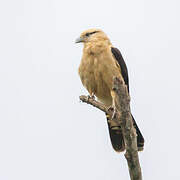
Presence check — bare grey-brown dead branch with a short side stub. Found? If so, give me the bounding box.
[80,77,142,180]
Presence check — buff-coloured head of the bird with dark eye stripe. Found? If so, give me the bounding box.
[75,29,109,44]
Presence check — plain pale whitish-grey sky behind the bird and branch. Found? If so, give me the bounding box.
[0,0,180,180]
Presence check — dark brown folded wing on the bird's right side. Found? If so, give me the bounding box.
[111,47,129,92]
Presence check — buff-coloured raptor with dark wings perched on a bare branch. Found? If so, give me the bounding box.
[75,28,144,152]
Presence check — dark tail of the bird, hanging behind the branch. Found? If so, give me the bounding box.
[107,115,144,152]
